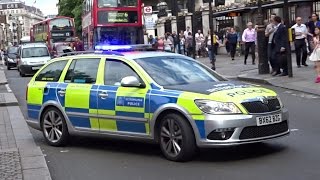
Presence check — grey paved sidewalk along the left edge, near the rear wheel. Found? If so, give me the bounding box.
[0,70,51,180]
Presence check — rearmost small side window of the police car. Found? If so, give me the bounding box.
[36,60,68,82]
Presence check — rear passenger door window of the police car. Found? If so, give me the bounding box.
[64,59,100,84]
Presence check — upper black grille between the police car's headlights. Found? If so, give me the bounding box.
[241,98,281,114]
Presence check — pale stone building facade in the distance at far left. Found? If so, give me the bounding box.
[0,0,44,45]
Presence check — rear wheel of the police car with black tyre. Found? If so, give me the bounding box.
[41,107,69,146]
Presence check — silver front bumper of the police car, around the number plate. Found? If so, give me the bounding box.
[197,109,290,147]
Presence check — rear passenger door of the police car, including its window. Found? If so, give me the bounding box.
[59,58,100,131]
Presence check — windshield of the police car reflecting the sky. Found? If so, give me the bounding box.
[135,56,225,87]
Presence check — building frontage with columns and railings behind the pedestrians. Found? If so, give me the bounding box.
[143,0,320,37]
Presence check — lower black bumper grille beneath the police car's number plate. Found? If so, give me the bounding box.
[239,121,289,139]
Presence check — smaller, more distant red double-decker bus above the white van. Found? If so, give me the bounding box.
[30,16,76,52]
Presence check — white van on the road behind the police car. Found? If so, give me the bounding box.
[17,43,51,77]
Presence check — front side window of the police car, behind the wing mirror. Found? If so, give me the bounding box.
[104,60,140,86]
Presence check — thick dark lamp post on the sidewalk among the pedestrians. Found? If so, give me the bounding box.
[257,0,270,74]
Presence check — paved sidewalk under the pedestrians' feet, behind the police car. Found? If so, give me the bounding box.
[198,55,320,95]
